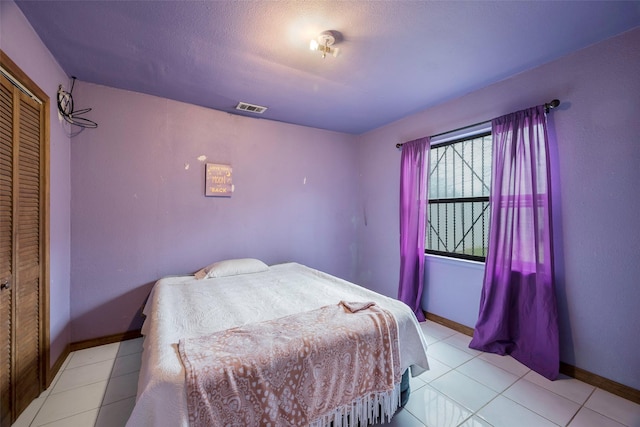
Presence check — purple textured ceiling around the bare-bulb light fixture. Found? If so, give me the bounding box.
[16,0,640,134]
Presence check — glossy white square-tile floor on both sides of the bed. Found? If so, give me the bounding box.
[12,321,640,427]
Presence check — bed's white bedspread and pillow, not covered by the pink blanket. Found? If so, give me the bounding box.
[127,259,428,427]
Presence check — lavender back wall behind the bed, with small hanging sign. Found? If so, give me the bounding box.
[71,82,357,341]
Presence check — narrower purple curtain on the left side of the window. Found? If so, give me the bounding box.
[398,137,429,321]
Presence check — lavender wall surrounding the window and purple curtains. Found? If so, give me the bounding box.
[357,29,640,389]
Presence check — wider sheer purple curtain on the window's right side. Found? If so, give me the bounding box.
[469,106,560,380]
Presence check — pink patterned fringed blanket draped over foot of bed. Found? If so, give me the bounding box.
[179,302,401,427]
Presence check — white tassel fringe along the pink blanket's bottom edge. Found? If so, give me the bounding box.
[309,383,400,427]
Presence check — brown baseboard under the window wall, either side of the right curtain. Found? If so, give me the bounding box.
[424,311,640,404]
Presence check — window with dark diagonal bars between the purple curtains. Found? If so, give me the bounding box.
[425,124,492,261]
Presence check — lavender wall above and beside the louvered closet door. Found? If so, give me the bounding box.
[0,0,71,364]
